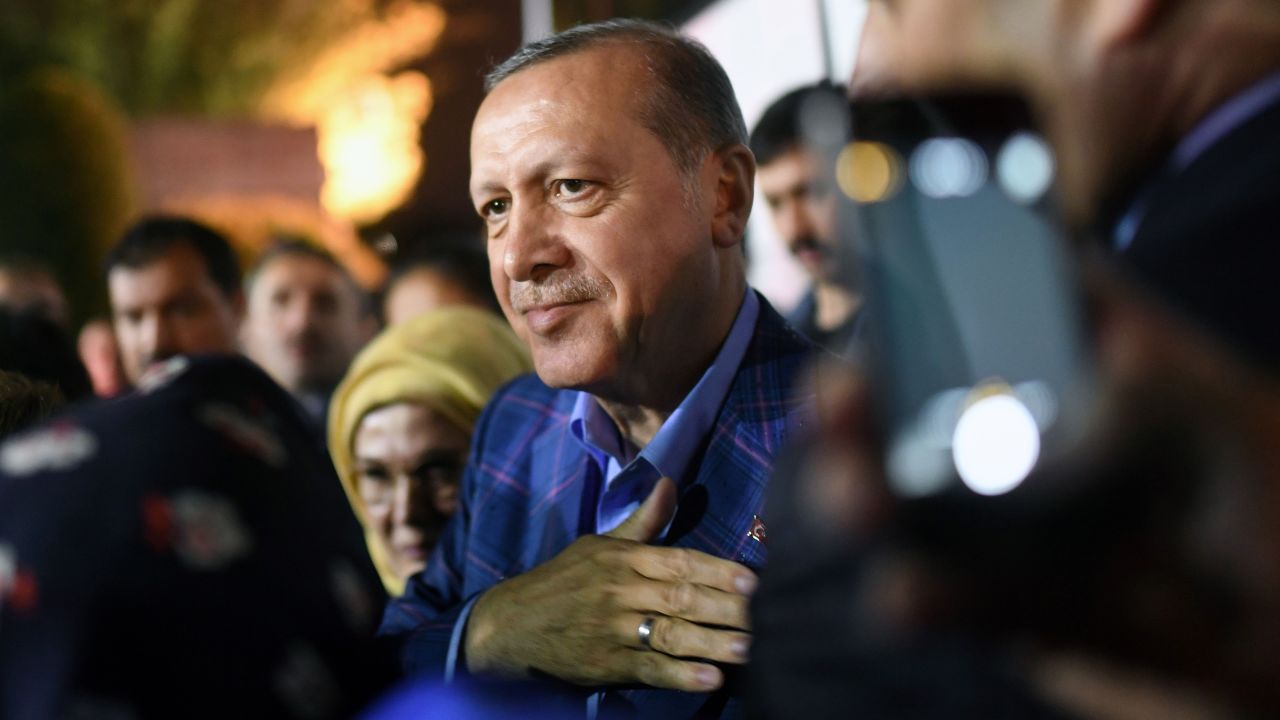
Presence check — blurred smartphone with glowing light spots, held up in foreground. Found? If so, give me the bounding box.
[835,96,1096,498]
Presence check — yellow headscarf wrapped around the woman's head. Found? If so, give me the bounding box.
[329,306,532,596]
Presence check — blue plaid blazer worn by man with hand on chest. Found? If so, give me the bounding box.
[380,297,814,717]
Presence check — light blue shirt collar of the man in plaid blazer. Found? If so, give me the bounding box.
[570,288,760,482]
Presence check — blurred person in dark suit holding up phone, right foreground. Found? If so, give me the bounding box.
[755,0,1280,719]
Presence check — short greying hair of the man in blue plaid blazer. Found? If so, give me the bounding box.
[484,19,748,178]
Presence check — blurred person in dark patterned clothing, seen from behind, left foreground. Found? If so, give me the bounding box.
[0,356,392,720]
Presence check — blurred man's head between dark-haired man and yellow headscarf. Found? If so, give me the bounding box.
[241,240,378,428]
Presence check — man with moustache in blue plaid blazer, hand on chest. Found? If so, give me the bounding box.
[381,20,813,717]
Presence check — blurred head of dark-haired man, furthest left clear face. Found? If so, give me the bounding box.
[106,217,244,386]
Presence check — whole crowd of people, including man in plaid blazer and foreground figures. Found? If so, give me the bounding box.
[0,0,1280,720]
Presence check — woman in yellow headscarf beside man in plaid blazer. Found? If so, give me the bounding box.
[329,306,532,596]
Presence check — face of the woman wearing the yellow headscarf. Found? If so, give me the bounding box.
[352,402,471,578]
